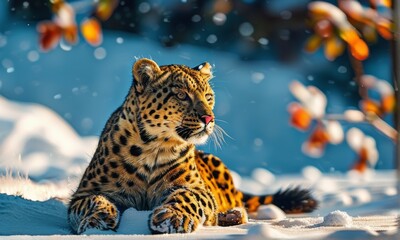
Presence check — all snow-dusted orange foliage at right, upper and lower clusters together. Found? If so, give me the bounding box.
[288,0,397,172]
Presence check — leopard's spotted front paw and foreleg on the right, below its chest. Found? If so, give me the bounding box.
[149,187,217,233]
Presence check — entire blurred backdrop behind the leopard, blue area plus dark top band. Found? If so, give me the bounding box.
[0,0,394,178]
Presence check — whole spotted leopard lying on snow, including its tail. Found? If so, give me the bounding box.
[67,58,318,234]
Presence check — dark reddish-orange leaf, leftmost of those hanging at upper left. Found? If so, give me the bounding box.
[37,21,62,51]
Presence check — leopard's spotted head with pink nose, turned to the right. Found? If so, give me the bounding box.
[132,59,215,144]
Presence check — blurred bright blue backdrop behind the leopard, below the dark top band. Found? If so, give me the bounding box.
[0,1,394,175]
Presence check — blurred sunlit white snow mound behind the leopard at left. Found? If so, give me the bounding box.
[0,96,98,180]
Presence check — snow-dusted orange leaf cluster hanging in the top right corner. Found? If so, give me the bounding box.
[305,0,393,61]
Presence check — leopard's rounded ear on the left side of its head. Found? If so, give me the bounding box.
[132,58,161,92]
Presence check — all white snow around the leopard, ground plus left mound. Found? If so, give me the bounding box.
[0,94,400,239]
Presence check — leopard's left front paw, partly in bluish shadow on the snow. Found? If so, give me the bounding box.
[68,195,120,234]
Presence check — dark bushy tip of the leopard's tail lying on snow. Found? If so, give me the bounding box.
[272,187,318,213]
